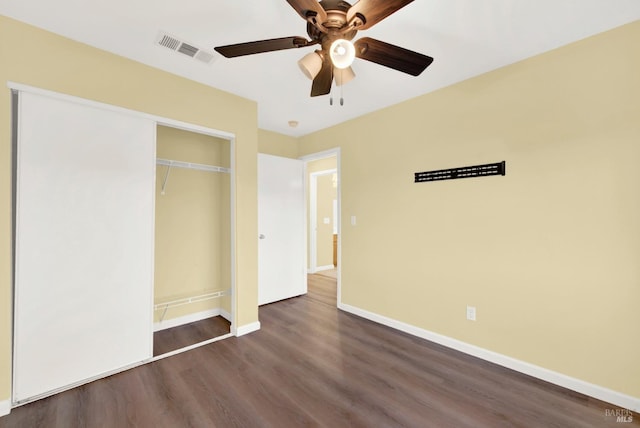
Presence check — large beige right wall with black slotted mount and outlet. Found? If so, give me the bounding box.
[300,22,640,397]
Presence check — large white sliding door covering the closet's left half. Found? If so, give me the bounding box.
[13,92,156,403]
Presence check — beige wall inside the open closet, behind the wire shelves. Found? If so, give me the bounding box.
[154,126,231,322]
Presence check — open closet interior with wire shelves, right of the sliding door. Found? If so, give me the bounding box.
[154,126,231,356]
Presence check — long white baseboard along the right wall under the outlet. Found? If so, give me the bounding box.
[338,303,640,412]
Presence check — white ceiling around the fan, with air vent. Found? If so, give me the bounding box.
[0,0,640,136]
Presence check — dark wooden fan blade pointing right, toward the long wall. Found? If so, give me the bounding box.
[354,36,433,76]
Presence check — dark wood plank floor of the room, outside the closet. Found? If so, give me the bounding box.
[0,275,640,428]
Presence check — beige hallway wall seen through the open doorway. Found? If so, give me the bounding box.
[307,156,338,267]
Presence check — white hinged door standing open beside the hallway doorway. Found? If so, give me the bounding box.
[258,154,307,305]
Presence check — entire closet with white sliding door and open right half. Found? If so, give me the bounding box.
[9,84,234,405]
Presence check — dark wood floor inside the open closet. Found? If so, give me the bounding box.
[153,316,231,357]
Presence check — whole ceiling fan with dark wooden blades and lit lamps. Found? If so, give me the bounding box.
[215,0,433,97]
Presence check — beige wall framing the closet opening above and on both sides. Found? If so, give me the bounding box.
[0,16,258,401]
